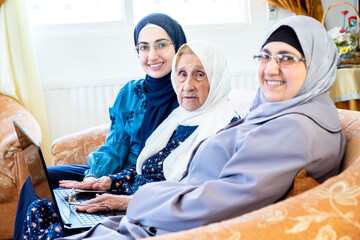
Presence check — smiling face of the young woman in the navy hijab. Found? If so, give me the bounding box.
[138,27,175,78]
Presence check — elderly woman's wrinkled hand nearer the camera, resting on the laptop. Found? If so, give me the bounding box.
[76,193,131,213]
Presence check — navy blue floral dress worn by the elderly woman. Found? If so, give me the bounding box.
[23,126,197,240]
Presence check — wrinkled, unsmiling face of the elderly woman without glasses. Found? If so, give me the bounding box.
[176,53,210,111]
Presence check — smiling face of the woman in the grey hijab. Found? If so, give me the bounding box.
[258,42,306,102]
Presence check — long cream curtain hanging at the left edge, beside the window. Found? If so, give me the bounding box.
[0,0,51,165]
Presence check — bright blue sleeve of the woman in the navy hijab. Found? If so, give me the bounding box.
[85,79,146,178]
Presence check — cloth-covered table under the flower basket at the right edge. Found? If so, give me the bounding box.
[328,68,360,111]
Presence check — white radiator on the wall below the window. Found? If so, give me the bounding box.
[43,71,258,140]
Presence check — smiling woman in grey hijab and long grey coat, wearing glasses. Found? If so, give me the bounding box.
[62,16,345,239]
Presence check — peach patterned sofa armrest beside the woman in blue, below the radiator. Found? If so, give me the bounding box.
[51,124,110,165]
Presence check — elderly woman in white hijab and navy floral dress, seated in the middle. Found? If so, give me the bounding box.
[53,41,238,212]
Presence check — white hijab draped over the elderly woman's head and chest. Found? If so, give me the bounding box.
[136,41,237,181]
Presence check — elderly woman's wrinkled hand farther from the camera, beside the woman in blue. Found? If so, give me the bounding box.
[59,176,111,191]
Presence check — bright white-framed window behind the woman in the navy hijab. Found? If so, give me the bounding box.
[26,0,249,35]
